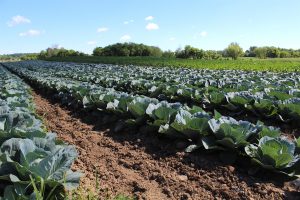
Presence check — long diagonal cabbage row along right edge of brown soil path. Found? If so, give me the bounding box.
[2,63,300,178]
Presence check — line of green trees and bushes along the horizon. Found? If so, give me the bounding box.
[38,43,300,60]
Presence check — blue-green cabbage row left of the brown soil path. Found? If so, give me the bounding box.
[0,66,80,199]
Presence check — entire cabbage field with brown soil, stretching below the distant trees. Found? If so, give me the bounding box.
[0,60,300,199]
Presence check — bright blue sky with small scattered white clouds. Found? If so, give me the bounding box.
[0,0,300,54]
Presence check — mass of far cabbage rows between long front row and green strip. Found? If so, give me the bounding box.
[13,61,300,125]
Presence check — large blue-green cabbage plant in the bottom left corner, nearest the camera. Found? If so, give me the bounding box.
[0,134,81,198]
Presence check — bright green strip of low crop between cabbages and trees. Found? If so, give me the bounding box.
[47,56,300,72]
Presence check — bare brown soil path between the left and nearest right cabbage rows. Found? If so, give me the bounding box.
[33,93,296,200]
